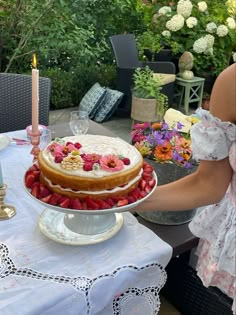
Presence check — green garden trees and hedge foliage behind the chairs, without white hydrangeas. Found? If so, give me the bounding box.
[0,0,236,109]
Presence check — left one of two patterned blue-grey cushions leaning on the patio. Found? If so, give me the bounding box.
[79,83,106,118]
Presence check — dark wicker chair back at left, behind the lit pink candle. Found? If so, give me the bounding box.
[0,73,51,132]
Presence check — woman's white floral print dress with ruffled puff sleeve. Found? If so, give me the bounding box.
[189,108,236,314]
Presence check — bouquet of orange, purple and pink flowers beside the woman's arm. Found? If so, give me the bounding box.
[131,118,197,168]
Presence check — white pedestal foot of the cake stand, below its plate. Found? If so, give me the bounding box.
[39,209,123,245]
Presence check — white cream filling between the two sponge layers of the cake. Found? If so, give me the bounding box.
[44,169,143,195]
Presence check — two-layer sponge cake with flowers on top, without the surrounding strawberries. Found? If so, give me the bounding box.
[38,135,143,200]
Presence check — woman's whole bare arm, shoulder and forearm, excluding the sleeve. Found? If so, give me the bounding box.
[134,64,236,211]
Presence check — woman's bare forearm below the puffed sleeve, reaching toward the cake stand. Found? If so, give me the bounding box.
[134,158,232,211]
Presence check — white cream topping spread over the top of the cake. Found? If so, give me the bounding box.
[42,135,142,178]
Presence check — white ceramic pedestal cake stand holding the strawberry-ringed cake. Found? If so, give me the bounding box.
[26,172,157,245]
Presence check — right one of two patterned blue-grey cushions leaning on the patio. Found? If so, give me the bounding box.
[94,88,124,122]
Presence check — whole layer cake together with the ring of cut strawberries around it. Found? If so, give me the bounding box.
[25,135,155,208]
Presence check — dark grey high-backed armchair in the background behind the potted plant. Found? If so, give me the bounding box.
[109,34,176,116]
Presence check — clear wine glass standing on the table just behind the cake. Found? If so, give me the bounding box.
[69,110,89,136]
